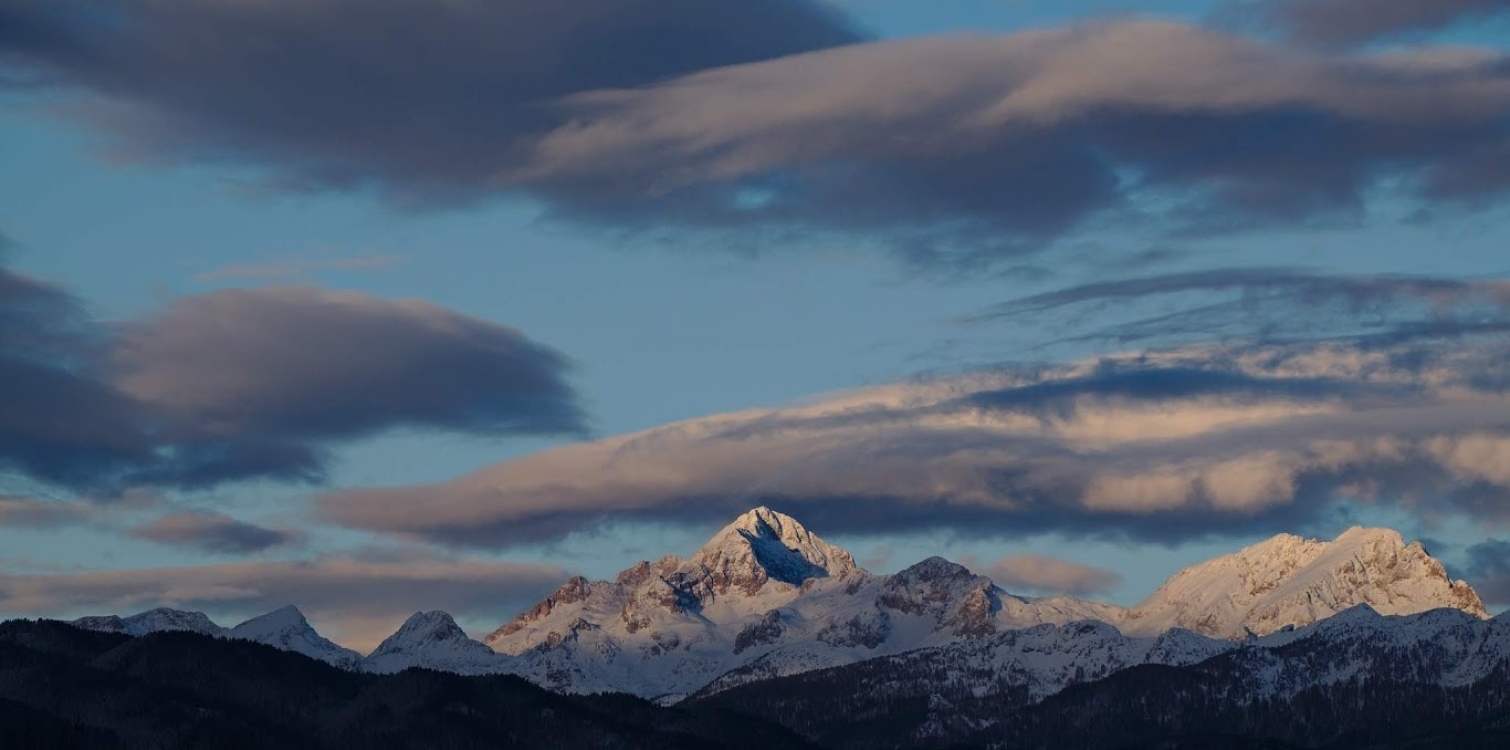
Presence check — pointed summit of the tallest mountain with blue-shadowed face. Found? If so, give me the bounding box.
[690,506,859,595]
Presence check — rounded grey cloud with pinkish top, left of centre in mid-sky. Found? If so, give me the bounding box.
[110,287,583,441]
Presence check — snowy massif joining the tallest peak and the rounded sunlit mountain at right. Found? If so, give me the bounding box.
[485,507,1486,699]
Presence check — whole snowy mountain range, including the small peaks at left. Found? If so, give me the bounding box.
[58,507,1487,703]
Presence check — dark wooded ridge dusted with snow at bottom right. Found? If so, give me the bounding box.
[689,605,1510,748]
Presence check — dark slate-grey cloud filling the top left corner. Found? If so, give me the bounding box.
[0,0,856,204]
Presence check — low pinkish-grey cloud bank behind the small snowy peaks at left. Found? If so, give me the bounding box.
[0,557,566,650]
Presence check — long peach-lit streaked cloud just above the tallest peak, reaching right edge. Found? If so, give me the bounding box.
[317,338,1510,546]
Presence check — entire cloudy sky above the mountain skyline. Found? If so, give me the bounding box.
[0,0,1510,649]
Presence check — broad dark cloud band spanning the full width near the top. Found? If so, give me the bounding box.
[0,10,1510,264]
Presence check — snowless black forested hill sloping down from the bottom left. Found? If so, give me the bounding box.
[0,620,811,750]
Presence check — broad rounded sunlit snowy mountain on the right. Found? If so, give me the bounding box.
[1108,527,1487,638]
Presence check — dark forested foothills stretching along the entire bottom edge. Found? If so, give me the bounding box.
[0,611,1510,750]
